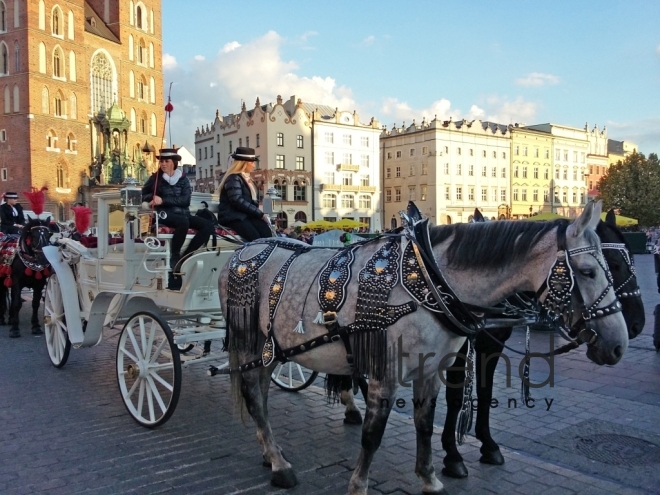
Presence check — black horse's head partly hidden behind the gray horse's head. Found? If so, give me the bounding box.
[596,210,646,339]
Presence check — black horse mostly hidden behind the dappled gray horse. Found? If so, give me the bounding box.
[442,210,645,478]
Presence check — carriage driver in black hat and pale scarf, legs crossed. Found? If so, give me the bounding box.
[142,149,213,290]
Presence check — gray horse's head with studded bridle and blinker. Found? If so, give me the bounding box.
[564,202,628,364]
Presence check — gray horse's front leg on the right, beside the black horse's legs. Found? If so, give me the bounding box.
[413,373,447,494]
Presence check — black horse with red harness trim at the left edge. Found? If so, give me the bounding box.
[0,218,52,337]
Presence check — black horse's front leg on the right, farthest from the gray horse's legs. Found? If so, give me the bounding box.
[474,328,513,466]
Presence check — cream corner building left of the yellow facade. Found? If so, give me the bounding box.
[380,118,511,228]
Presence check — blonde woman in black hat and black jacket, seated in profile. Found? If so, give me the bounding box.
[218,147,273,241]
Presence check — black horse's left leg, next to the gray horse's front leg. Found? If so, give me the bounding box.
[441,340,469,478]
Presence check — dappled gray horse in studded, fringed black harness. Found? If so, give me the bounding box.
[219,203,628,494]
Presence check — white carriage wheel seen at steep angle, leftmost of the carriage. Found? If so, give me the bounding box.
[44,274,71,368]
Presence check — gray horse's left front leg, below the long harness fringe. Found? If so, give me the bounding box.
[348,376,397,495]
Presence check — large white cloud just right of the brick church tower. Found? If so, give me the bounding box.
[163,31,359,147]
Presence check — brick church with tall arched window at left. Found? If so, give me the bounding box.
[0,0,164,220]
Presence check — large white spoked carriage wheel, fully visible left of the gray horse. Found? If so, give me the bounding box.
[117,311,181,428]
